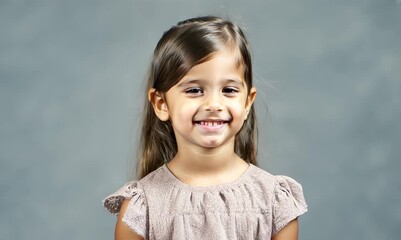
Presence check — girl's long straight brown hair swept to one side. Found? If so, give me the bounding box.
[138,16,257,178]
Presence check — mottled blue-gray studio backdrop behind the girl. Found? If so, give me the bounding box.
[0,0,401,239]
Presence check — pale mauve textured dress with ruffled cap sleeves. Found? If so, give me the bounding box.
[103,165,307,240]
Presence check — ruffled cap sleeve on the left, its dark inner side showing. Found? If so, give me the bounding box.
[103,181,148,239]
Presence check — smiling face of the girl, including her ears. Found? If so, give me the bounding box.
[150,50,256,150]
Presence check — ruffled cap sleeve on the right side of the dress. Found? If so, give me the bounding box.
[272,176,308,235]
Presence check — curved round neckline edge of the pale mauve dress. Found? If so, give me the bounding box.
[162,163,255,191]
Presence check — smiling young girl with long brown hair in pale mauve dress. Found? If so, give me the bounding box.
[104,17,307,240]
